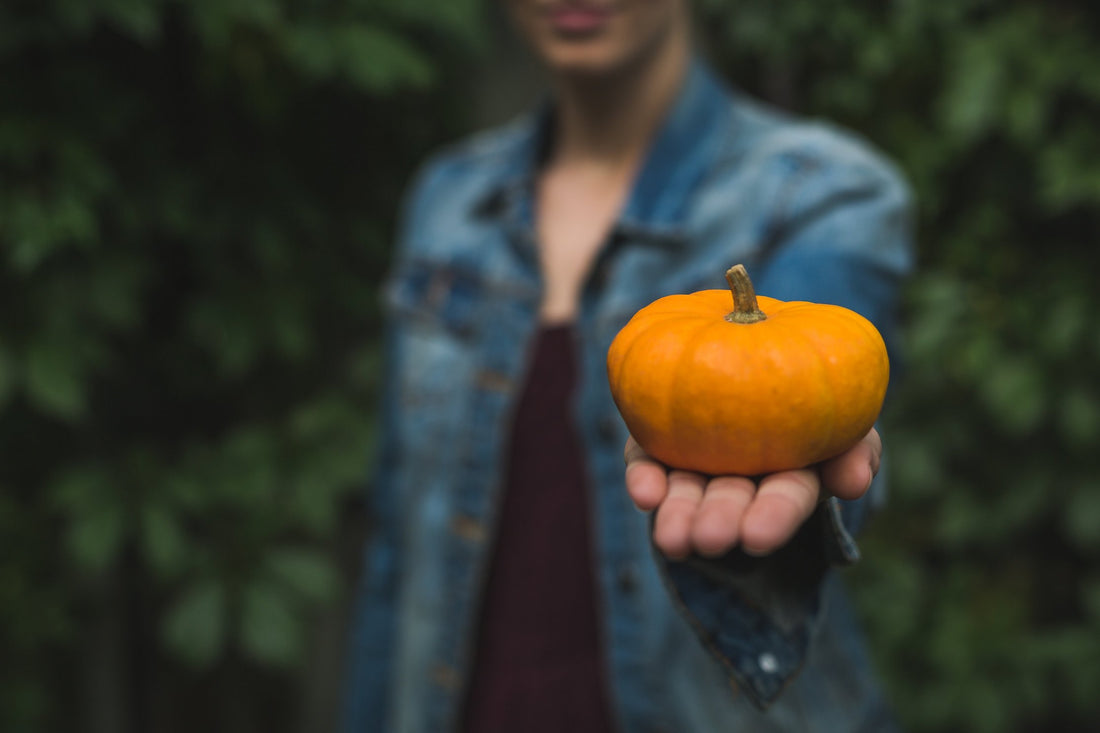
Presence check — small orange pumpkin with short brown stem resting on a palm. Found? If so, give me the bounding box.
[607,265,890,475]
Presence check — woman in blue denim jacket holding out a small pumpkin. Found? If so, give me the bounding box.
[348,0,910,733]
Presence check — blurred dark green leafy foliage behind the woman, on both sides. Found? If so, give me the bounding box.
[0,0,1100,733]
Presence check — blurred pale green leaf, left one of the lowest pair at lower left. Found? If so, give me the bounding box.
[162,579,228,667]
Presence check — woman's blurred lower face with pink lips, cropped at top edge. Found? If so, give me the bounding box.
[504,0,689,76]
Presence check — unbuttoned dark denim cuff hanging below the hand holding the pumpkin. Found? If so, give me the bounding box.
[653,499,866,709]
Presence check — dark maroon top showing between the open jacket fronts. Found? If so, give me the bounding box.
[462,326,612,733]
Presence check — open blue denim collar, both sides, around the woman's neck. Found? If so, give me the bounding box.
[474,58,734,245]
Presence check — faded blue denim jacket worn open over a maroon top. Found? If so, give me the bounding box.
[345,63,911,733]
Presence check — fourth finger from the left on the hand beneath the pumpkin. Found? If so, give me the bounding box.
[741,469,821,555]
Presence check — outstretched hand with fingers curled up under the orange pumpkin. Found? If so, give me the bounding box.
[624,428,882,559]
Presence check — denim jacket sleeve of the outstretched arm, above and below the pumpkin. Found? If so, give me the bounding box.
[655,147,911,708]
